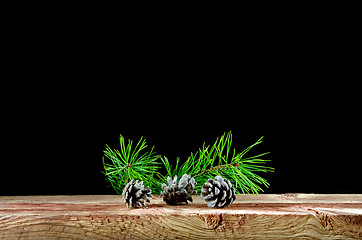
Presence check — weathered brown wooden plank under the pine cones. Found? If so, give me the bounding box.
[0,194,362,240]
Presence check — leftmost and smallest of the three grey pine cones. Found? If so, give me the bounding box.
[122,179,152,208]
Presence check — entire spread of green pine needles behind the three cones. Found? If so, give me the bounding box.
[103,132,274,194]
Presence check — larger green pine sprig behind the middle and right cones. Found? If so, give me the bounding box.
[158,132,274,194]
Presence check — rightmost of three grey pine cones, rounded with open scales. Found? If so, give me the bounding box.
[200,175,236,208]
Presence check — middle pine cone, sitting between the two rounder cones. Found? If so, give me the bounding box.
[161,174,196,205]
